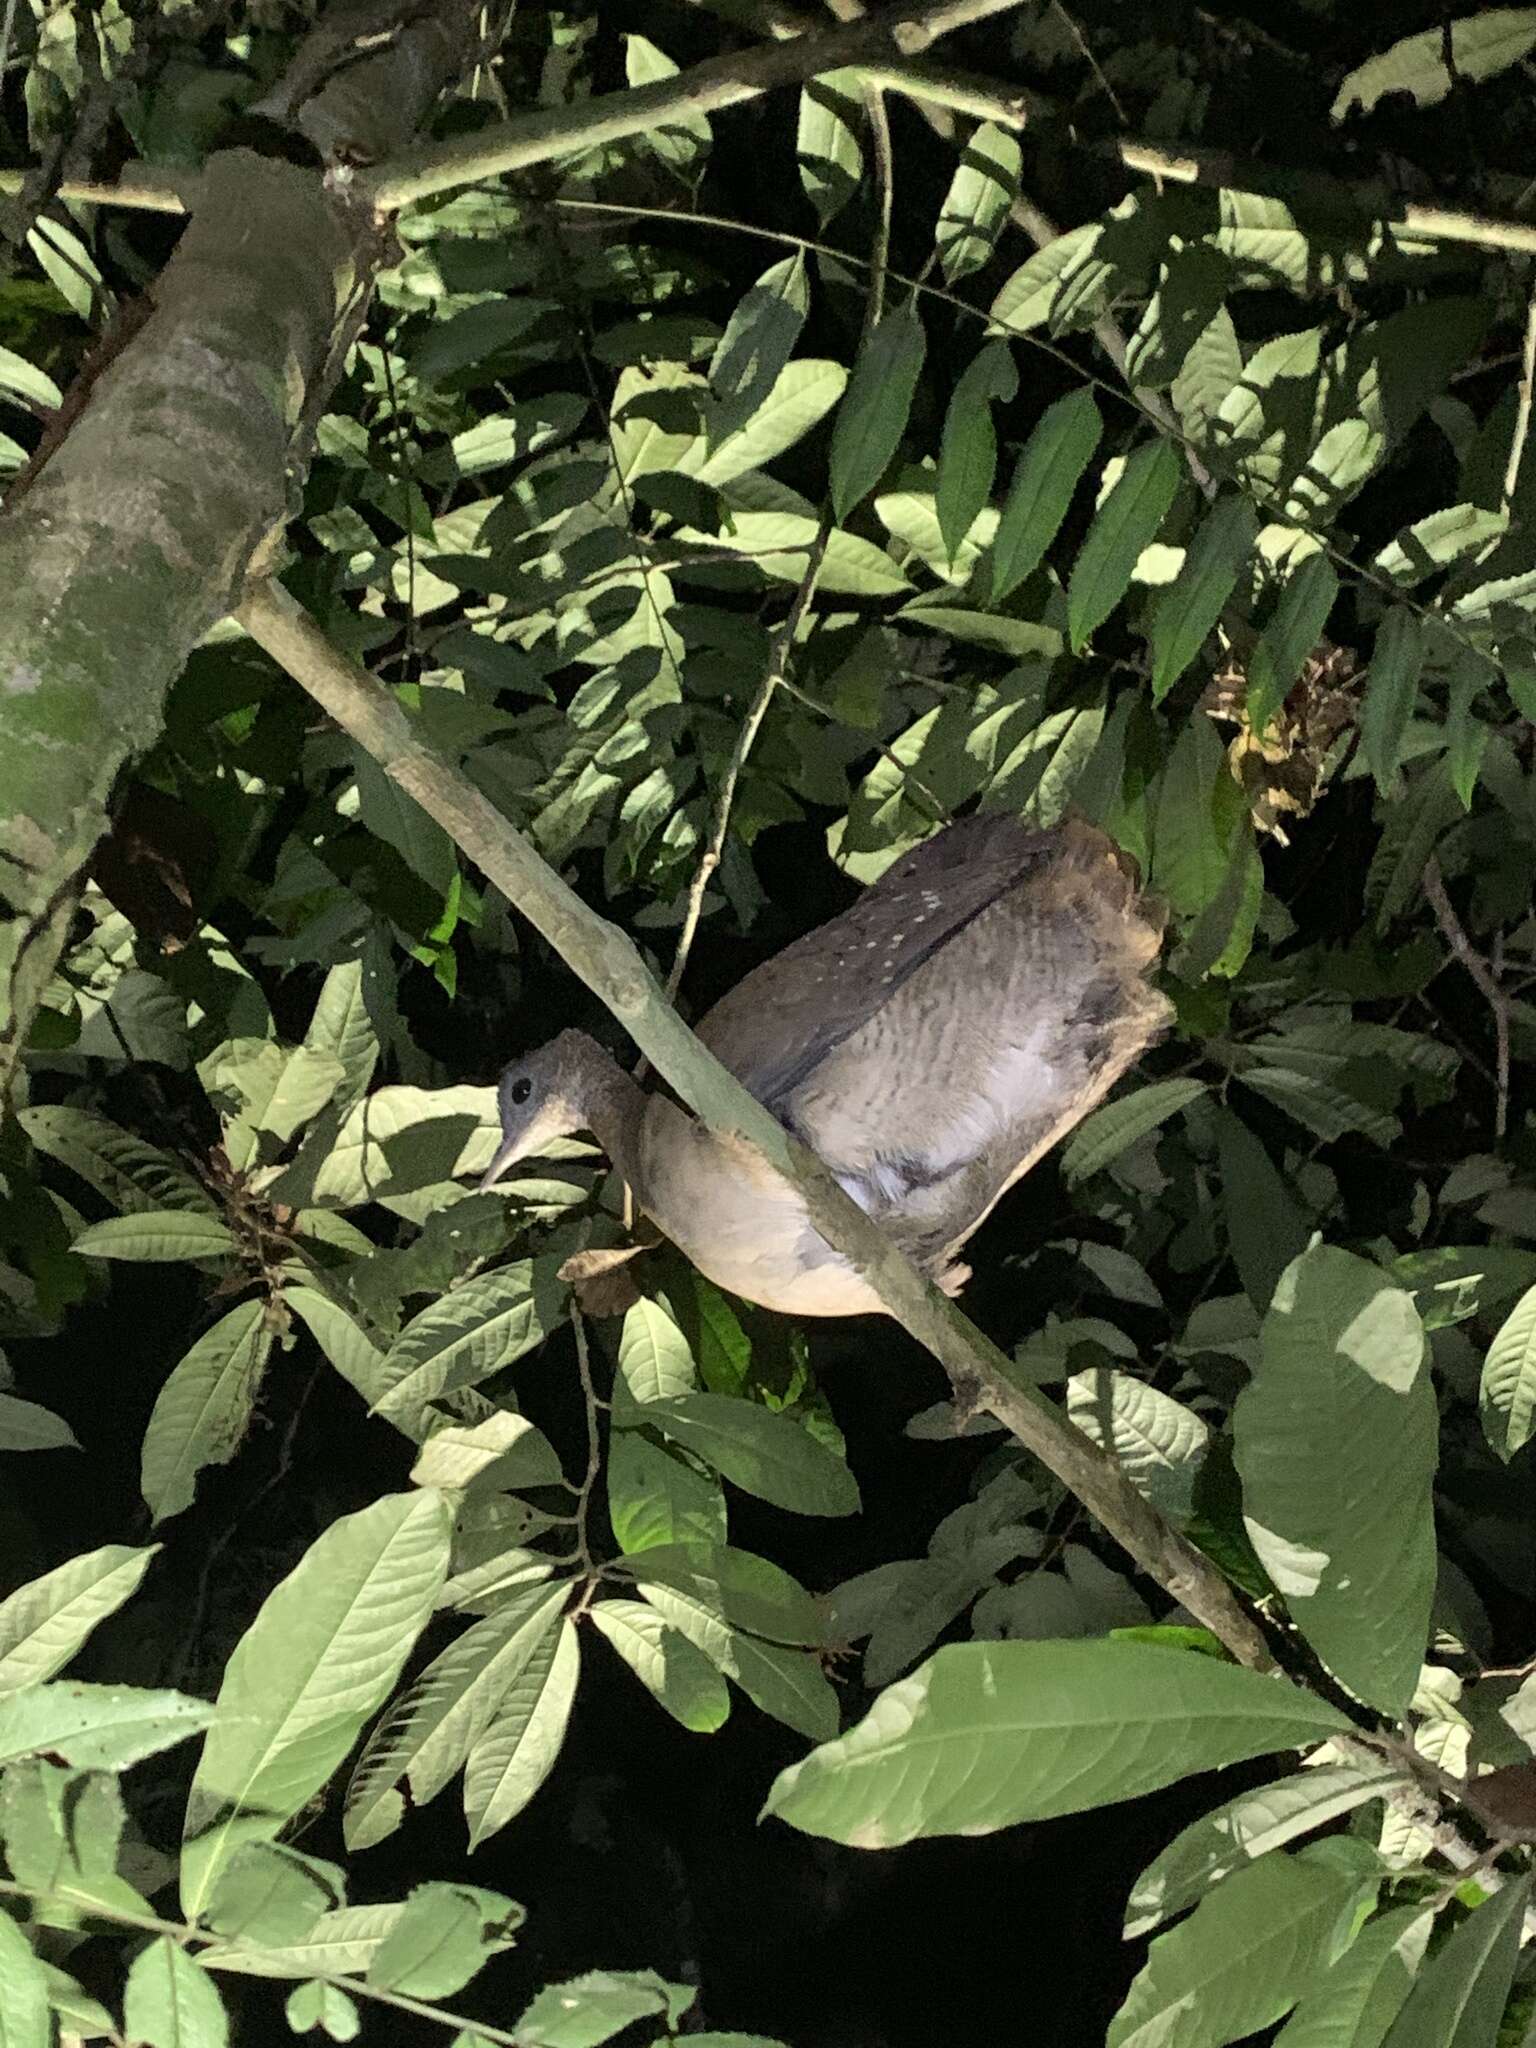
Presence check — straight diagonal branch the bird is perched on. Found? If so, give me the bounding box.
[236,584,1272,1671]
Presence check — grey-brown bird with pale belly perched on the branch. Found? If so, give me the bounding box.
[479,813,1171,1317]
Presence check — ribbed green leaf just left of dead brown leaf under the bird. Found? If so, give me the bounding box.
[377,1260,559,1421]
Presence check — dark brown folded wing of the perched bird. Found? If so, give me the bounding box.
[698,815,1056,1108]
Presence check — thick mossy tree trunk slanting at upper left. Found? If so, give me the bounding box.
[0,0,477,1098]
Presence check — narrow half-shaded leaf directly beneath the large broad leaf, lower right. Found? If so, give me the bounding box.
[1124,1763,1407,1939]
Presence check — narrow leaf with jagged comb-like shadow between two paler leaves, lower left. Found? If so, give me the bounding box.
[342,1583,569,1849]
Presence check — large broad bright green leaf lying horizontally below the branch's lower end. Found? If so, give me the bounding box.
[766,1640,1348,1849]
